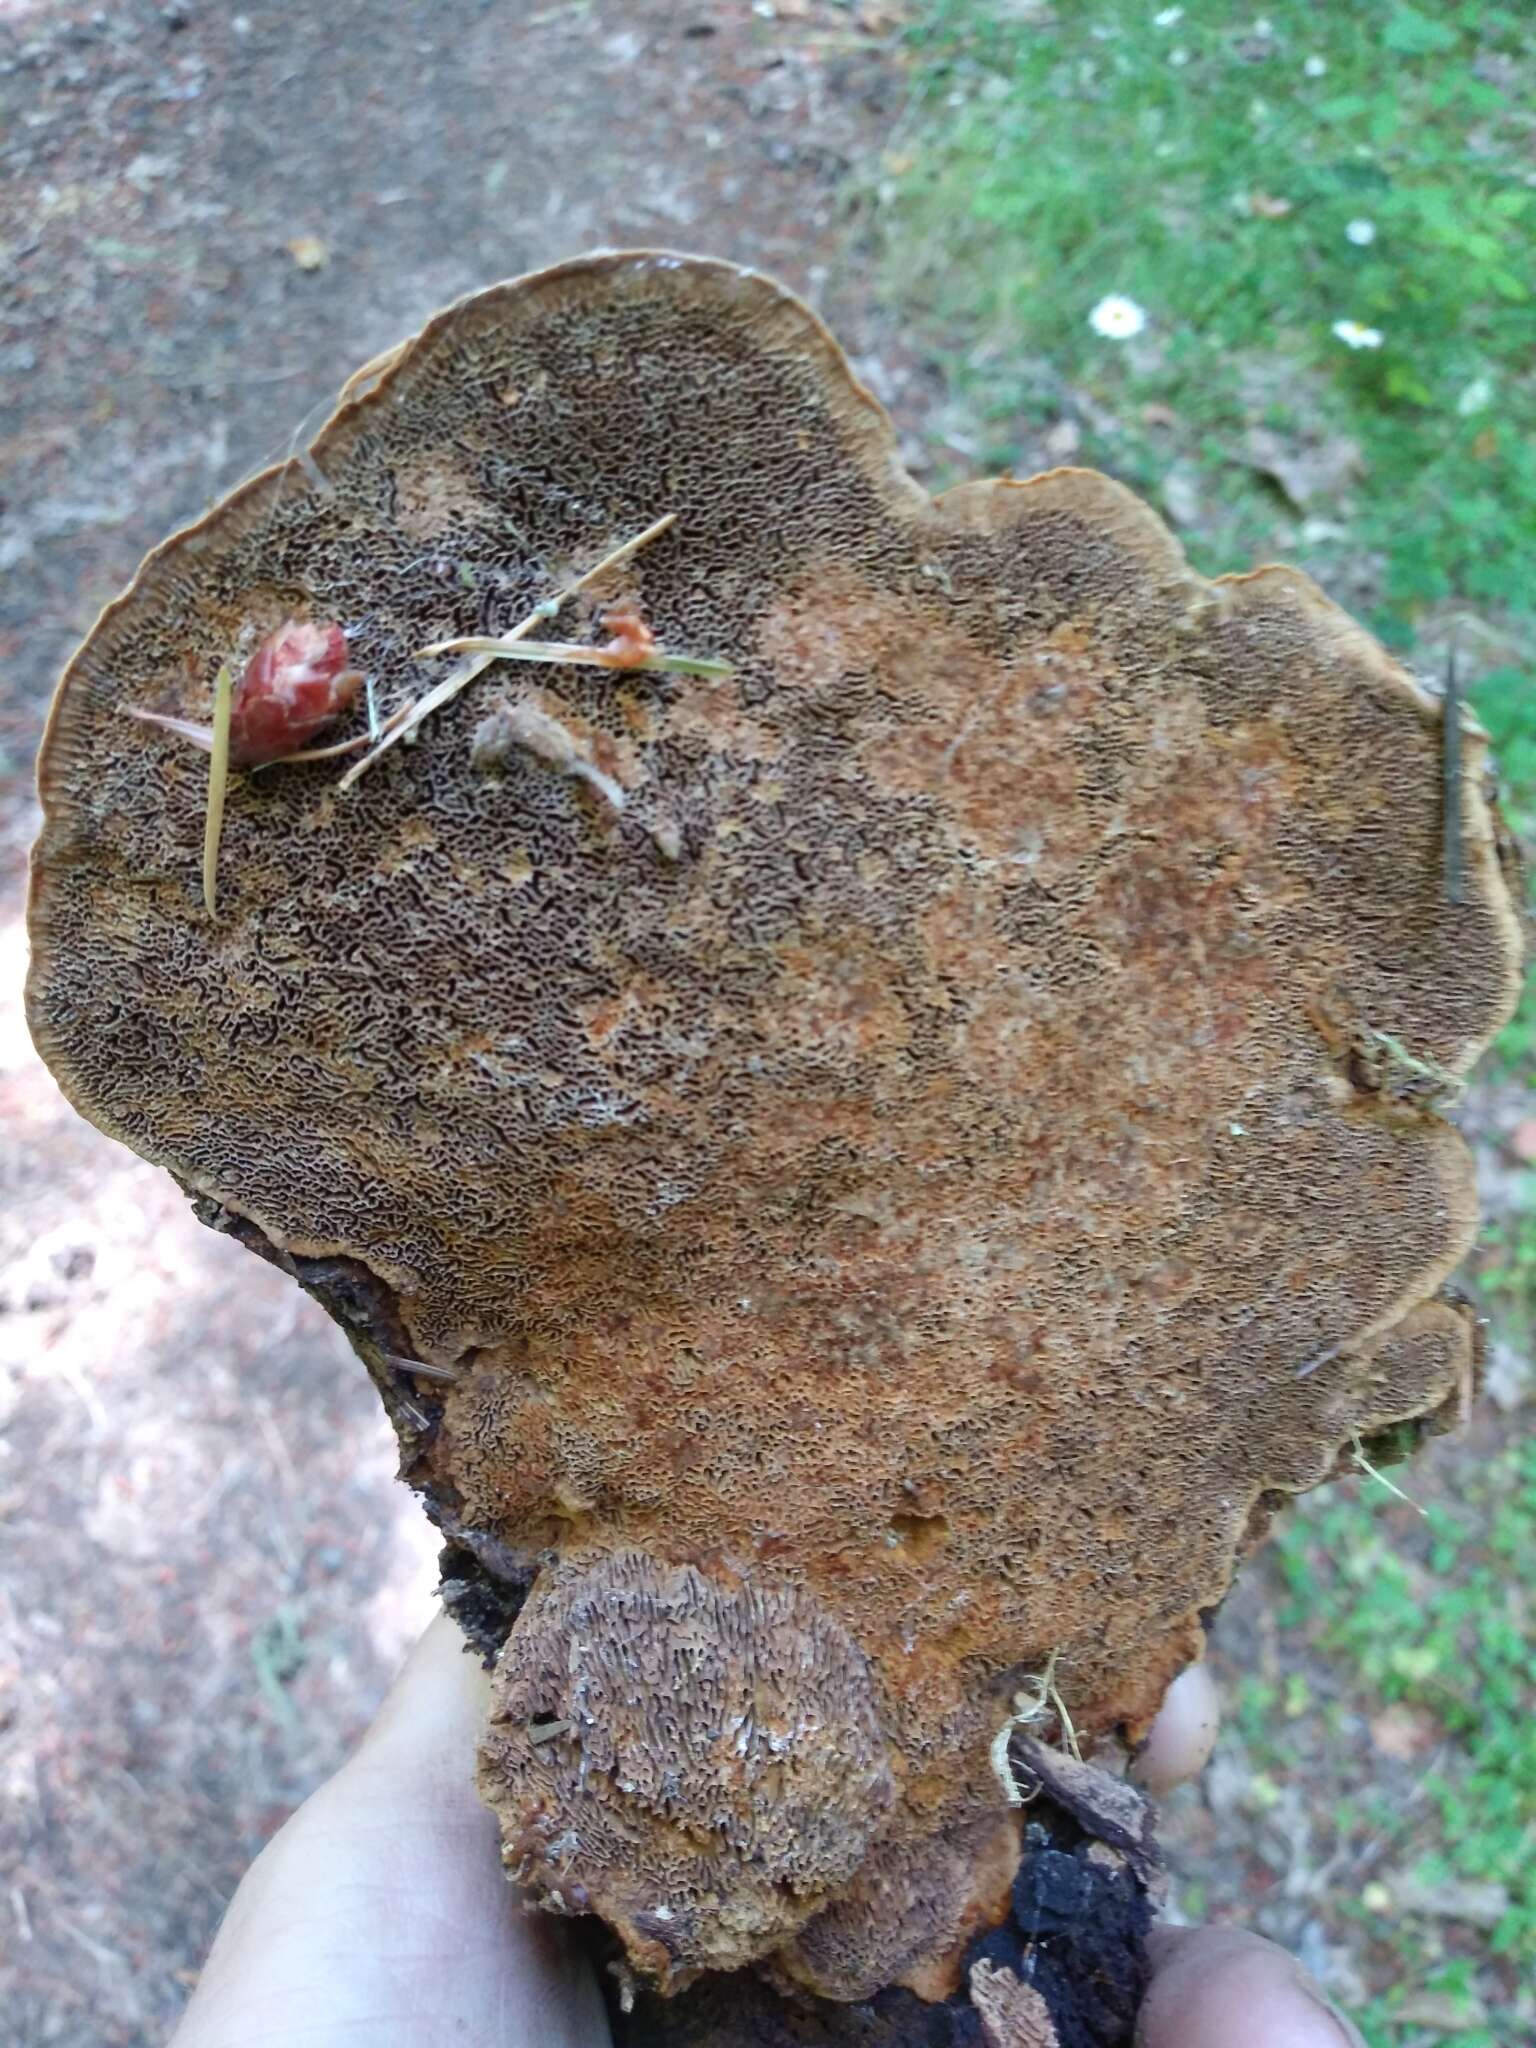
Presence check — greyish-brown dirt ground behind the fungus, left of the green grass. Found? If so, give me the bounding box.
[0,0,1531,2048]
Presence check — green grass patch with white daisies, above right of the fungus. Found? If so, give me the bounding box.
[885,0,1536,641]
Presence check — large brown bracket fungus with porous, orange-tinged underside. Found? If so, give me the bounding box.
[29,252,1520,2044]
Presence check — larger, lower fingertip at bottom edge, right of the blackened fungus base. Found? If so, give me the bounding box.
[1137,1927,1366,2048]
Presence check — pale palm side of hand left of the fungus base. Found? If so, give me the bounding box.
[172,1614,608,2048]
